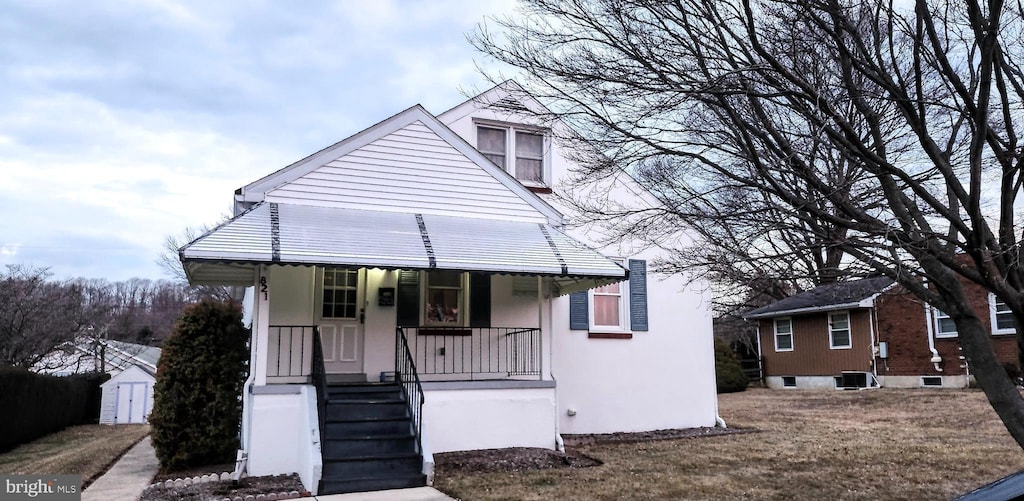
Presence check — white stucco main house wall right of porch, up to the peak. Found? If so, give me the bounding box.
[440,89,718,433]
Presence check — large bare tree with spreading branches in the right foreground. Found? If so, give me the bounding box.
[475,0,1024,447]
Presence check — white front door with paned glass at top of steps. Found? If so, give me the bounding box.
[318,268,366,374]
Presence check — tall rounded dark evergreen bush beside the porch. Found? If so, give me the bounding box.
[150,300,249,471]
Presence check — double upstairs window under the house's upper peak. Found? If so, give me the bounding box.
[476,124,549,186]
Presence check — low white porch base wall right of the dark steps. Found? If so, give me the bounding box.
[423,388,555,453]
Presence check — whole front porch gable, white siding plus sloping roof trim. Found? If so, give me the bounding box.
[236,105,562,224]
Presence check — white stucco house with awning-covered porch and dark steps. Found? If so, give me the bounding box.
[180,82,717,494]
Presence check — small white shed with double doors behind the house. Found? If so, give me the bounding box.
[99,365,157,424]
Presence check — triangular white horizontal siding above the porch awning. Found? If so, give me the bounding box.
[266,121,547,222]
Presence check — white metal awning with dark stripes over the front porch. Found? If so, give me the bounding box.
[179,202,627,295]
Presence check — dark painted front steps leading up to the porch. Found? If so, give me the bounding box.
[319,382,427,494]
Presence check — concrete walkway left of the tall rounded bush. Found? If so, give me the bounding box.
[82,436,160,501]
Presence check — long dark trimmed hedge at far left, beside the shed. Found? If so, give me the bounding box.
[0,366,111,452]
